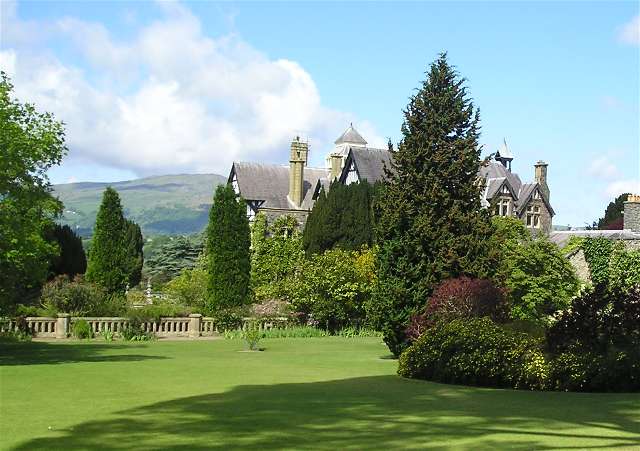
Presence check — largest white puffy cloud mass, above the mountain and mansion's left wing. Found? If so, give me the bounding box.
[0,3,385,175]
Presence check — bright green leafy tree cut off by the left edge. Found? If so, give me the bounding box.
[0,72,67,313]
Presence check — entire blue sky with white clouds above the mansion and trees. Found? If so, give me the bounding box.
[0,2,640,226]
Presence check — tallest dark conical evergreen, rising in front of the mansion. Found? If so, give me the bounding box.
[368,54,492,355]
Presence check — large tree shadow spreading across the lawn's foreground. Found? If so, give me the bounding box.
[17,376,640,450]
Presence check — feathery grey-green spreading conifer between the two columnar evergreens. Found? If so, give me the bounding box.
[145,235,206,282]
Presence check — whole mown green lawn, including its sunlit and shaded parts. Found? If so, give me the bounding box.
[0,337,640,450]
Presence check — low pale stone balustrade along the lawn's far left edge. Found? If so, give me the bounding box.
[0,313,287,338]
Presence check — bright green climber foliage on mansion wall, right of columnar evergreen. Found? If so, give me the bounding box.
[251,213,304,301]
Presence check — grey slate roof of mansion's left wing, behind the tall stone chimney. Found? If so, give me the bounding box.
[229,162,329,210]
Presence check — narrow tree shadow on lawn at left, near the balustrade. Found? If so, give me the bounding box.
[0,342,167,366]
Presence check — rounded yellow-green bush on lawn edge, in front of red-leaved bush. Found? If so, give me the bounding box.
[398,318,549,389]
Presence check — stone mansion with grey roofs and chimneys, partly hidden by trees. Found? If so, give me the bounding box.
[229,125,554,233]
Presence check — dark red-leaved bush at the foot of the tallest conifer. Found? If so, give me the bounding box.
[405,277,508,341]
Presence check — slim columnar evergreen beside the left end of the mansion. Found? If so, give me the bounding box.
[206,185,251,311]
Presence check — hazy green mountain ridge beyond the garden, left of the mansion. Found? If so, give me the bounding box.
[53,174,227,237]
